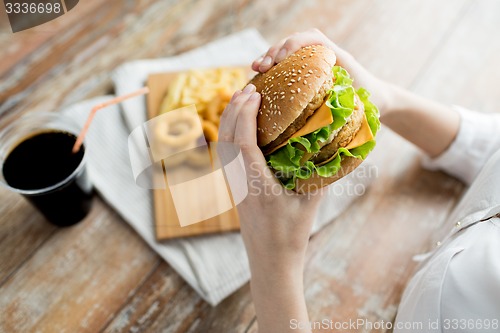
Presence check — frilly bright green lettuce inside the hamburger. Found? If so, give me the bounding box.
[267,66,380,189]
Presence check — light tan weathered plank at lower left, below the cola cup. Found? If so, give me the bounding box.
[0,199,159,333]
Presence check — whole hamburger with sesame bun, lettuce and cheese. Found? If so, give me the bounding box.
[250,45,380,193]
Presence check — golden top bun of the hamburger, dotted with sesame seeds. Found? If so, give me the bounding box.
[254,45,336,151]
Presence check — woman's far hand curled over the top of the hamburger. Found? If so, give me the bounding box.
[252,29,393,116]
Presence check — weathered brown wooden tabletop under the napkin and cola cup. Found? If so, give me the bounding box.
[0,0,500,333]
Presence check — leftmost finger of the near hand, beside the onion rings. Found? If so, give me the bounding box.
[219,84,255,142]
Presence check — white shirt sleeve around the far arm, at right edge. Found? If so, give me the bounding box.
[422,106,500,184]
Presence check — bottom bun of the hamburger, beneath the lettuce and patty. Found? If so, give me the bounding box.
[294,156,363,194]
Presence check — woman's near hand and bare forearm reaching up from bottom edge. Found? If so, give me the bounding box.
[219,85,320,332]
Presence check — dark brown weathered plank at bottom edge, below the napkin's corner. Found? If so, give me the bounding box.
[103,263,255,333]
